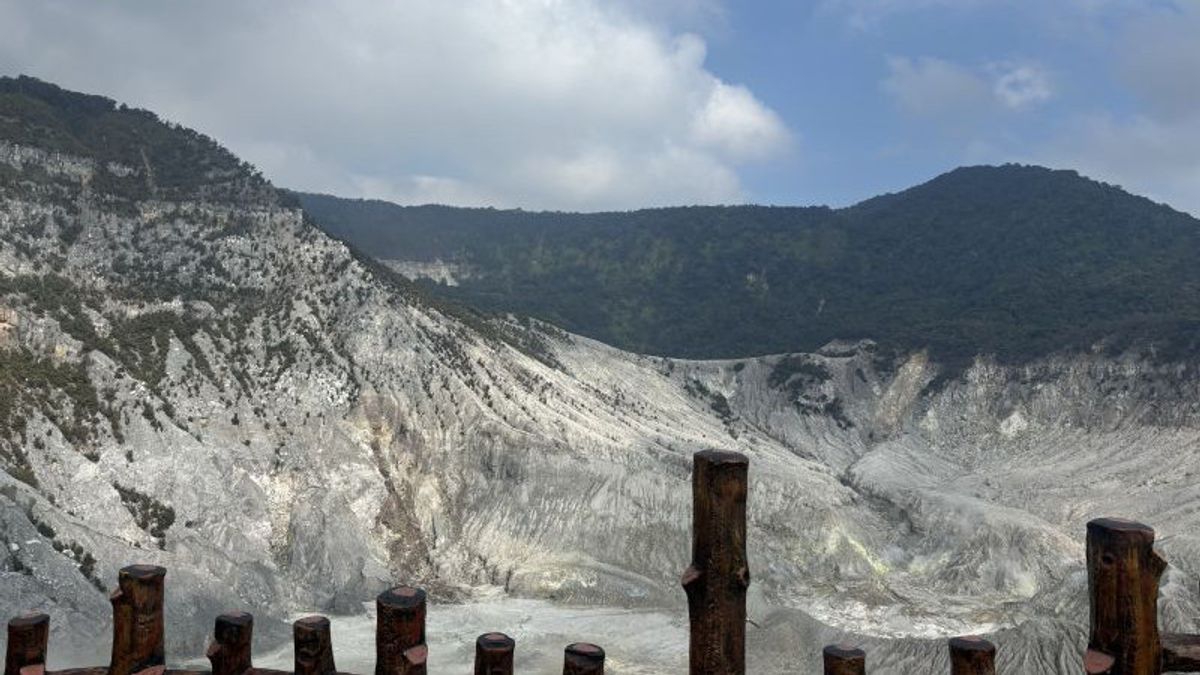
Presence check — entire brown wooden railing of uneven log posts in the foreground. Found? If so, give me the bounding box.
[5,450,1200,675]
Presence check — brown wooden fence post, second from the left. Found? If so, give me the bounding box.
[108,565,167,675]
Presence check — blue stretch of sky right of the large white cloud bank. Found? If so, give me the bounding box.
[697,0,1200,213]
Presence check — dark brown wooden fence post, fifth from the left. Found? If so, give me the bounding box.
[376,586,428,675]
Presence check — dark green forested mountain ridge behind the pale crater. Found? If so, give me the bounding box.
[298,165,1200,364]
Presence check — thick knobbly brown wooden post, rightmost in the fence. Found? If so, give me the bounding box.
[1086,518,1166,675]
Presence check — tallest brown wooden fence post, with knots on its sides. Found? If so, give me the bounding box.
[682,450,750,675]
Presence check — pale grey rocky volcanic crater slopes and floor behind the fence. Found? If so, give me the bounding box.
[7,78,1200,674]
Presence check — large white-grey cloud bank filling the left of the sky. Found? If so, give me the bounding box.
[0,0,791,209]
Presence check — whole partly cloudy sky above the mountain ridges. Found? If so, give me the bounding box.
[0,0,1200,214]
